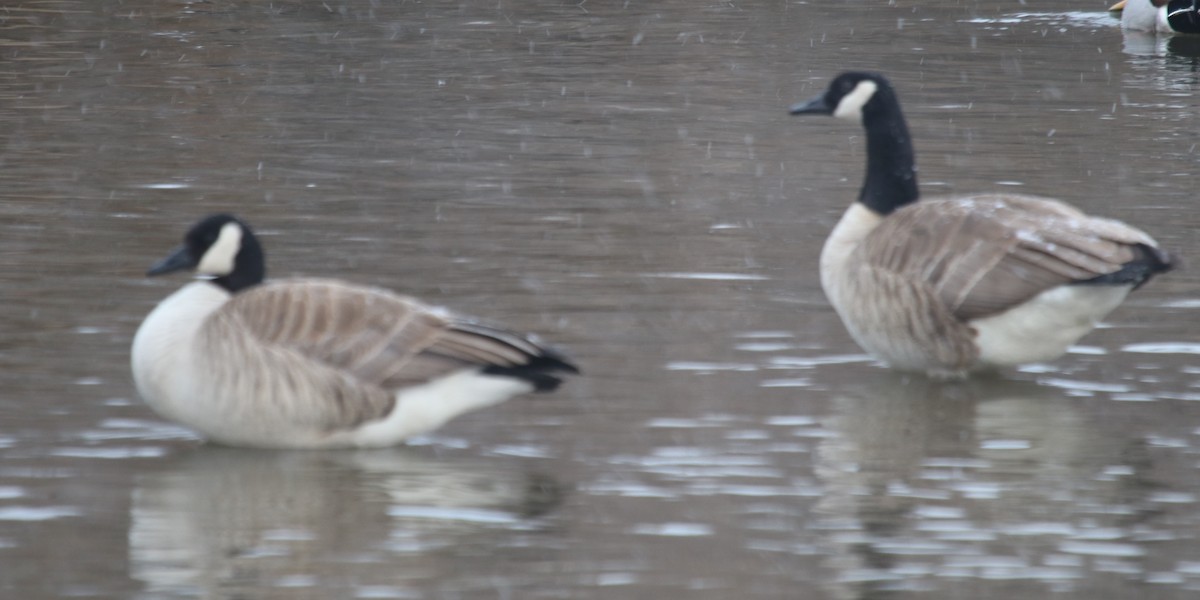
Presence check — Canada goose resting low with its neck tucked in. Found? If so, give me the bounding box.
[131,215,578,448]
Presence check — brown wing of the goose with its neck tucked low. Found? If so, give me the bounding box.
[206,280,566,428]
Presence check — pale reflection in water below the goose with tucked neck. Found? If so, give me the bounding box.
[130,448,563,598]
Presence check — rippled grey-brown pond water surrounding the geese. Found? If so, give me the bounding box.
[0,0,1200,600]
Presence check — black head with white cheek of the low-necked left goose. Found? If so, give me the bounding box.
[146,214,266,292]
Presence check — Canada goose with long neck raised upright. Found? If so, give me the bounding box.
[791,72,1176,377]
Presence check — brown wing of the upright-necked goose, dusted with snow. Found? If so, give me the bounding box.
[860,194,1153,320]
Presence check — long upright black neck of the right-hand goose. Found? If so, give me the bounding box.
[858,100,919,215]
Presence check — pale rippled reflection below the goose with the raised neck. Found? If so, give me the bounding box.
[814,378,1200,598]
